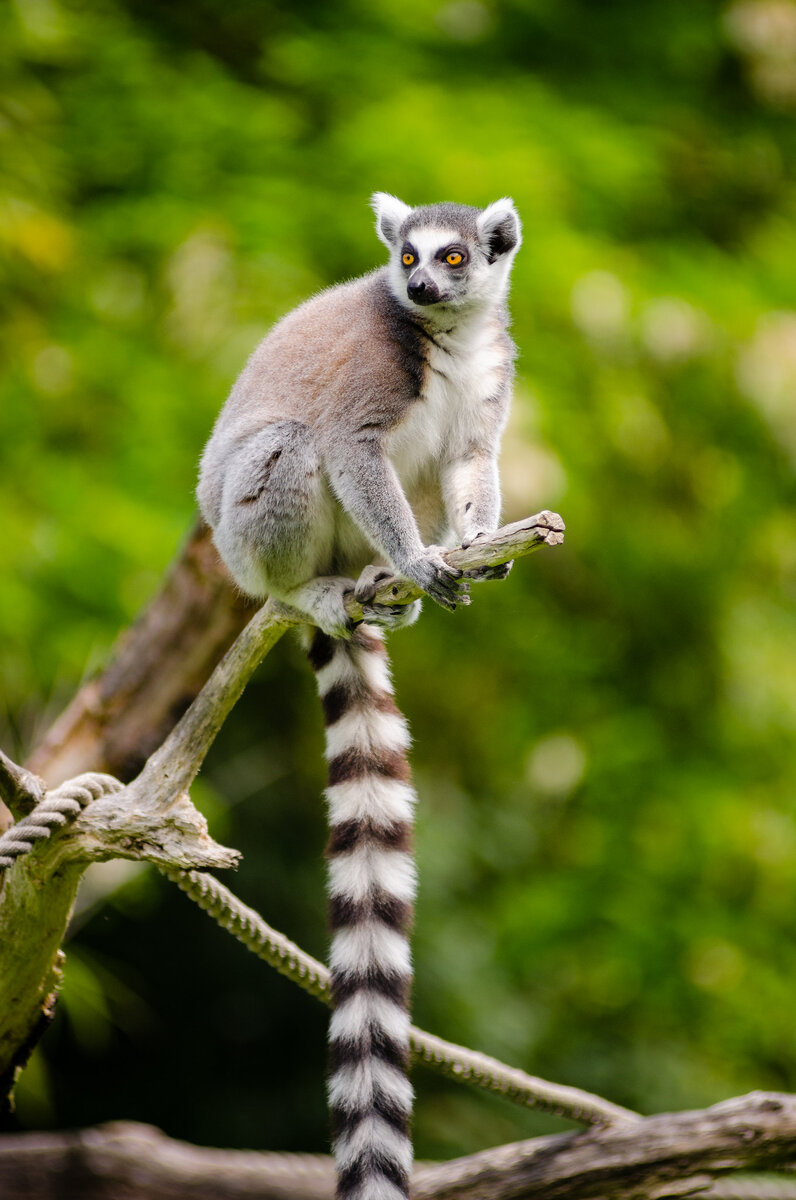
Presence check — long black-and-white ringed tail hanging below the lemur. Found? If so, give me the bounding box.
[310,625,415,1200]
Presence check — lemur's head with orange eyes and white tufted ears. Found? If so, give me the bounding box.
[371,192,522,318]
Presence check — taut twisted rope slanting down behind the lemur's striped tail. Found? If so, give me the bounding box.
[160,868,639,1126]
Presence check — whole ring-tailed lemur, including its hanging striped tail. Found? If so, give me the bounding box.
[197,192,521,1200]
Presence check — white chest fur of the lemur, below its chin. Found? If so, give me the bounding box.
[387,320,508,486]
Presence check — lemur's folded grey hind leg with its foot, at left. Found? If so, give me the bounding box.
[215,421,354,637]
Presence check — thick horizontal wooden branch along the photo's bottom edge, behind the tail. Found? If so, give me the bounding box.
[0,1092,796,1200]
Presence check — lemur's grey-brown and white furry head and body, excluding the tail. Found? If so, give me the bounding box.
[197,193,520,637]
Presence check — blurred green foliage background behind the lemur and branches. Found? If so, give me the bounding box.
[0,0,796,1156]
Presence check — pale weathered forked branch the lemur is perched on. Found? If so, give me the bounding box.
[0,511,563,1104]
